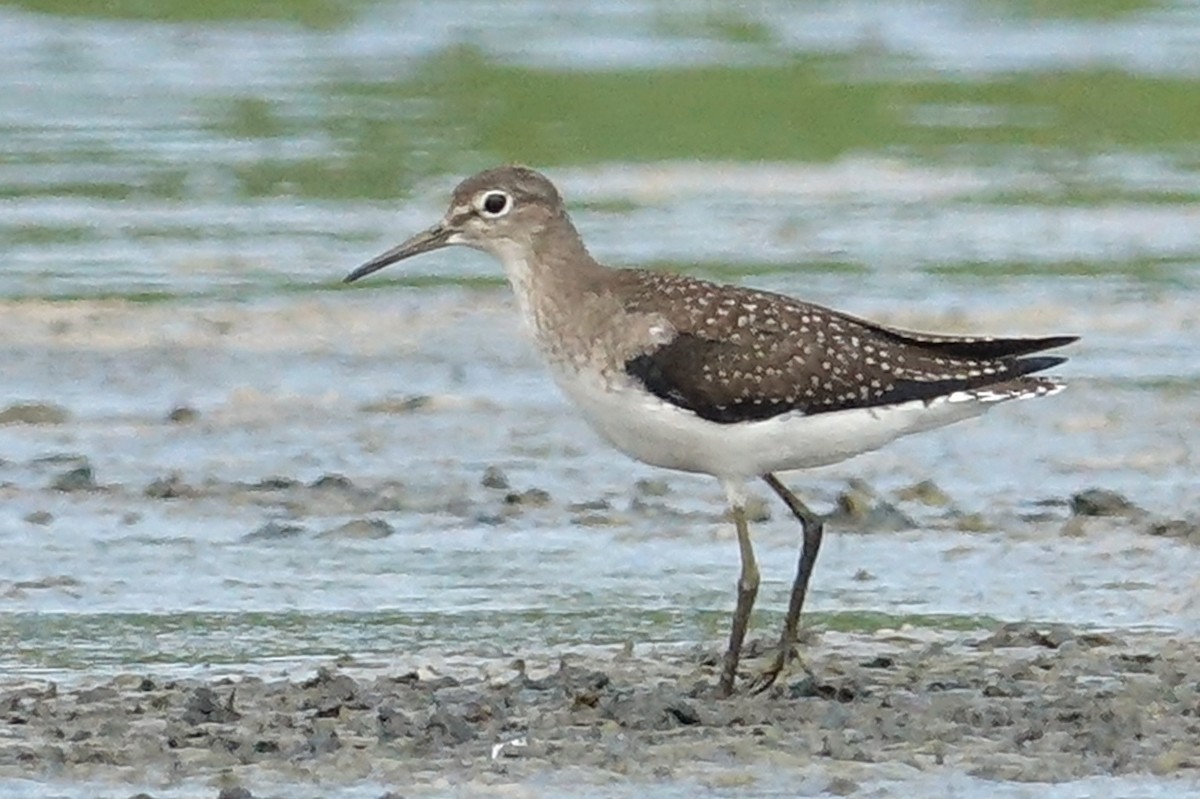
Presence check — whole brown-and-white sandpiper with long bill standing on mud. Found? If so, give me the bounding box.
[346,166,1075,696]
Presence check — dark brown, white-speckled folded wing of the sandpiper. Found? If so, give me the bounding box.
[624,274,1074,423]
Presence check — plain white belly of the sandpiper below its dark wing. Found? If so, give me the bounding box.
[554,370,988,479]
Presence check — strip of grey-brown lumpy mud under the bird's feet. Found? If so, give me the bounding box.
[0,624,1200,794]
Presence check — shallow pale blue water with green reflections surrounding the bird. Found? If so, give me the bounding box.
[0,0,1200,795]
